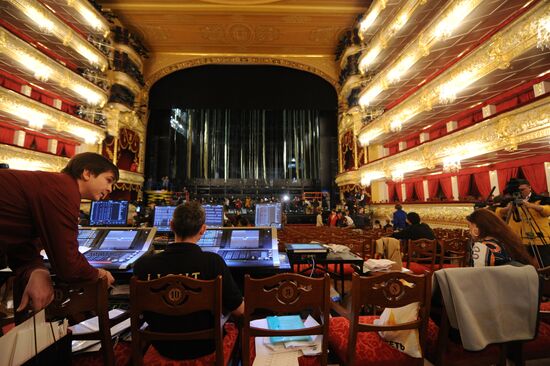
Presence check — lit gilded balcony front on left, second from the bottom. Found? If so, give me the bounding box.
[0,87,105,144]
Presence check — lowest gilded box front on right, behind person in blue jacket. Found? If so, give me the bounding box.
[376,203,473,228]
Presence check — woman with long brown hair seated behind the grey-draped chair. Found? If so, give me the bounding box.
[466,208,535,267]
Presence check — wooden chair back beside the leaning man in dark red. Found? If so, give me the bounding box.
[46,278,128,366]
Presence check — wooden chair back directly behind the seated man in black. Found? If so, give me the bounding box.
[130,275,224,366]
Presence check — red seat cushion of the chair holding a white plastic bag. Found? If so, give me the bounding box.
[328,316,418,366]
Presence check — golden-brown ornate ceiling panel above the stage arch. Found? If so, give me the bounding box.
[99,0,370,83]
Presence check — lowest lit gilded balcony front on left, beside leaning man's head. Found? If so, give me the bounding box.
[0,144,69,172]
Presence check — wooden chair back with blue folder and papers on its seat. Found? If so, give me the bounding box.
[242,273,330,366]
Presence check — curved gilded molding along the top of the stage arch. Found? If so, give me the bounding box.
[143,56,337,95]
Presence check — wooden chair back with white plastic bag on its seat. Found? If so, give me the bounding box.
[347,271,431,365]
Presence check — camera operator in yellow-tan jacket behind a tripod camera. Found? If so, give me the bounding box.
[496,179,550,267]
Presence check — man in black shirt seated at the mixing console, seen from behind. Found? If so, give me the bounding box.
[134,202,244,359]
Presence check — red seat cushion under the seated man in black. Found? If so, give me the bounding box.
[143,323,239,366]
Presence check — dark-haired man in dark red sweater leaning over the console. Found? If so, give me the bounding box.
[0,153,118,311]
